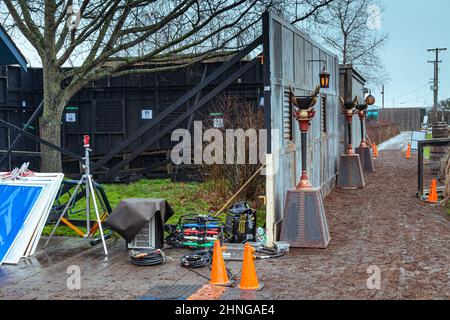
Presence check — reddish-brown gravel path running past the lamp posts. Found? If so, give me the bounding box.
[257,151,450,299]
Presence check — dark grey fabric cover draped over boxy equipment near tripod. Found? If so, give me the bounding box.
[106,199,173,242]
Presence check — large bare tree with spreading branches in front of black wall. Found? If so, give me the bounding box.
[0,0,338,171]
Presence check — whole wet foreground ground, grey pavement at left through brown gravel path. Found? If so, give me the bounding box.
[0,150,450,300]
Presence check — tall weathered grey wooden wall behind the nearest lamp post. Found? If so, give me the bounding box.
[264,14,339,240]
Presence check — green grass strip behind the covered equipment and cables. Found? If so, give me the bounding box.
[44,179,265,236]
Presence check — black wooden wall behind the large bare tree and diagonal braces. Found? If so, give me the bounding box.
[0,61,263,173]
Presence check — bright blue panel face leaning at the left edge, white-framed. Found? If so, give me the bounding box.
[0,184,43,262]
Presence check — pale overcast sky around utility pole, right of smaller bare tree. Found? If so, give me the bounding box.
[375,0,450,107]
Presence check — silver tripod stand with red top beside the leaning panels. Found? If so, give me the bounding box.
[44,135,108,256]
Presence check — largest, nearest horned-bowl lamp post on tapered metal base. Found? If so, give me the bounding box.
[280,89,331,249]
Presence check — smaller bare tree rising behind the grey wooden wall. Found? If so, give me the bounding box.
[315,0,388,84]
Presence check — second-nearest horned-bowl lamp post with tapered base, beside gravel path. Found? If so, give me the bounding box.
[337,99,366,190]
